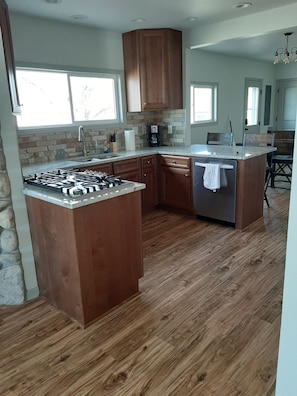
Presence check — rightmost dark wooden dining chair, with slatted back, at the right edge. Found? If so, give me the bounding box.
[268,131,295,187]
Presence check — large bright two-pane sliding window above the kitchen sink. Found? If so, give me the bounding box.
[16,68,122,129]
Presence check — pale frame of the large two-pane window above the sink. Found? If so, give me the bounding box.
[16,63,126,134]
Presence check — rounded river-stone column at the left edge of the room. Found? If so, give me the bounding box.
[0,136,25,305]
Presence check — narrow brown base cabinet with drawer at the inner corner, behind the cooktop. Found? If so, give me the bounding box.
[141,155,158,213]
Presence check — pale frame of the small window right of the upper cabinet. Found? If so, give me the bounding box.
[190,82,219,126]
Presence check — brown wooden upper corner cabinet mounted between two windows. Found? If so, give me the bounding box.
[122,29,182,112]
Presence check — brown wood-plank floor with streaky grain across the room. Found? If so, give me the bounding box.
[0,188,289,396]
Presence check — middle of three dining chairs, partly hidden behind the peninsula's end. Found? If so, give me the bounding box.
[243,133,275,207]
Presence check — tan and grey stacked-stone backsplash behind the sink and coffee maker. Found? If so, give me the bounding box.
[18,109,185,165]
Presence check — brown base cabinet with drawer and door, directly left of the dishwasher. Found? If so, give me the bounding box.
[159,155,193,213]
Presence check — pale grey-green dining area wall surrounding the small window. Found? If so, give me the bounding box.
[190,50,275,144]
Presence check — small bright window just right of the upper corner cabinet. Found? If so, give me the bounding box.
[191,83,218,124]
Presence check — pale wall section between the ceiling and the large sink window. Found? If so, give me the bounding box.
[10,14,123,70]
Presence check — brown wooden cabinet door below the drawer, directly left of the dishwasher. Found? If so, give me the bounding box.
[159,166,193,212]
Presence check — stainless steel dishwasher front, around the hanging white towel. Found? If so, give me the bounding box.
[192,157,237,223]
